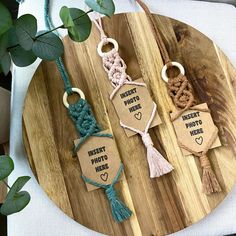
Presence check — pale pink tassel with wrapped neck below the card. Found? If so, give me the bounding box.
[142,133,174,178]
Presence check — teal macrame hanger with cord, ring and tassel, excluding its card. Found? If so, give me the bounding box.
[44,0,132,222]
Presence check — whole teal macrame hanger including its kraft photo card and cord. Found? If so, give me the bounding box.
[45,0,132,222]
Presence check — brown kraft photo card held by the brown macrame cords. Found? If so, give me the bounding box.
[170,103,221,155]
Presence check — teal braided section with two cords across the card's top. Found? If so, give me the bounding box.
[69,99,112,154]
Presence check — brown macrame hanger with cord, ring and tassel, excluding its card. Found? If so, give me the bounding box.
[136,0,221,194]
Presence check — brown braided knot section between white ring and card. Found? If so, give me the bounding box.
[168,74,195,109]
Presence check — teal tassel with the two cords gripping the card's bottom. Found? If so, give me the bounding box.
[82,164,132,222]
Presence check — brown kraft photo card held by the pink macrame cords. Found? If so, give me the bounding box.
[112,78,162,137]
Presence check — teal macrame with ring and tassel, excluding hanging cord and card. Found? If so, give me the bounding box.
[63,89,132,222]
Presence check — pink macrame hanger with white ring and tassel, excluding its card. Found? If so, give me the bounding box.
[94,17,173,178]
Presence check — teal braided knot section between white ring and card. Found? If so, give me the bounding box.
[69,99,100,137]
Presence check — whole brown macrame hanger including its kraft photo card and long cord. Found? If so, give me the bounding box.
[136,0,221,194]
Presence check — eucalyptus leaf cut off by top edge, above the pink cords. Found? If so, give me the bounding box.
[85,0,115,17]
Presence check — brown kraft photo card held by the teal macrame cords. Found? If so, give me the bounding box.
[74,130,121,191]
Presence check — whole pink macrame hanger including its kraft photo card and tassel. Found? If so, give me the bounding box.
[94,17,173,178]
